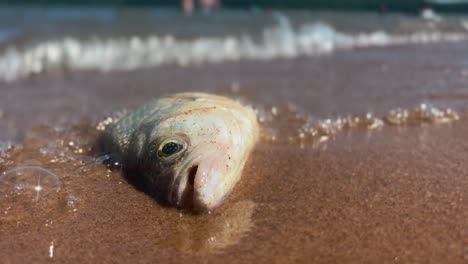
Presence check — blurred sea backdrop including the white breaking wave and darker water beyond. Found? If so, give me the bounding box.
[0,0,468,84]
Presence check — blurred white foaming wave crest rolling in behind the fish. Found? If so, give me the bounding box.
[0,14,468,81]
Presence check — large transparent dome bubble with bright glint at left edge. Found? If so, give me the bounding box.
[0,166,66,220]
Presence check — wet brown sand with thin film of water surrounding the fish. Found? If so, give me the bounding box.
[0,42,468,263]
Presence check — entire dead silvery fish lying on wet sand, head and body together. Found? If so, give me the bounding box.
[101,92,259,211]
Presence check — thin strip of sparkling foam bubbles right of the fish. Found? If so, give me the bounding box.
[257,103,460,146]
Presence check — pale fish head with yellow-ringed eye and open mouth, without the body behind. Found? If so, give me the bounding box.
[135,96,258,211]
